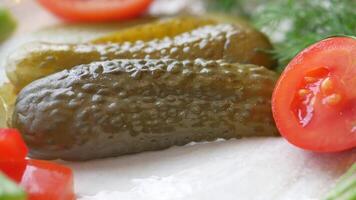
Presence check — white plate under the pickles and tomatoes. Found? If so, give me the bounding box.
[0,1,356,200]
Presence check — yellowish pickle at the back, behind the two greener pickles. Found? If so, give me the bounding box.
[92,16,216,44]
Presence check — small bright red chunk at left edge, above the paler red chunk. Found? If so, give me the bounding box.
[0,129,28,161]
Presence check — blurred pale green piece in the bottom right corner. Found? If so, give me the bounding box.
[324,163,356,200]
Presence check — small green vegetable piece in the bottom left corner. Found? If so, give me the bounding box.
[0,172,26,200]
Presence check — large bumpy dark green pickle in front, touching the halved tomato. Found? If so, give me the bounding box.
[13,59,277,160]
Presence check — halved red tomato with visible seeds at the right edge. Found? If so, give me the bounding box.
[272,37,356,152]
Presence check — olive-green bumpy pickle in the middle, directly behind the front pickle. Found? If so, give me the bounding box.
[6,24,275,91]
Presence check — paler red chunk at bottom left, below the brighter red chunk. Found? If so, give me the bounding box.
[0,160,75,200]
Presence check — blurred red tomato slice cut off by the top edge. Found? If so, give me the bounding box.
[38,0,153,22]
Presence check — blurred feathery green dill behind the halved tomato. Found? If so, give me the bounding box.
[210,0,356,71]
